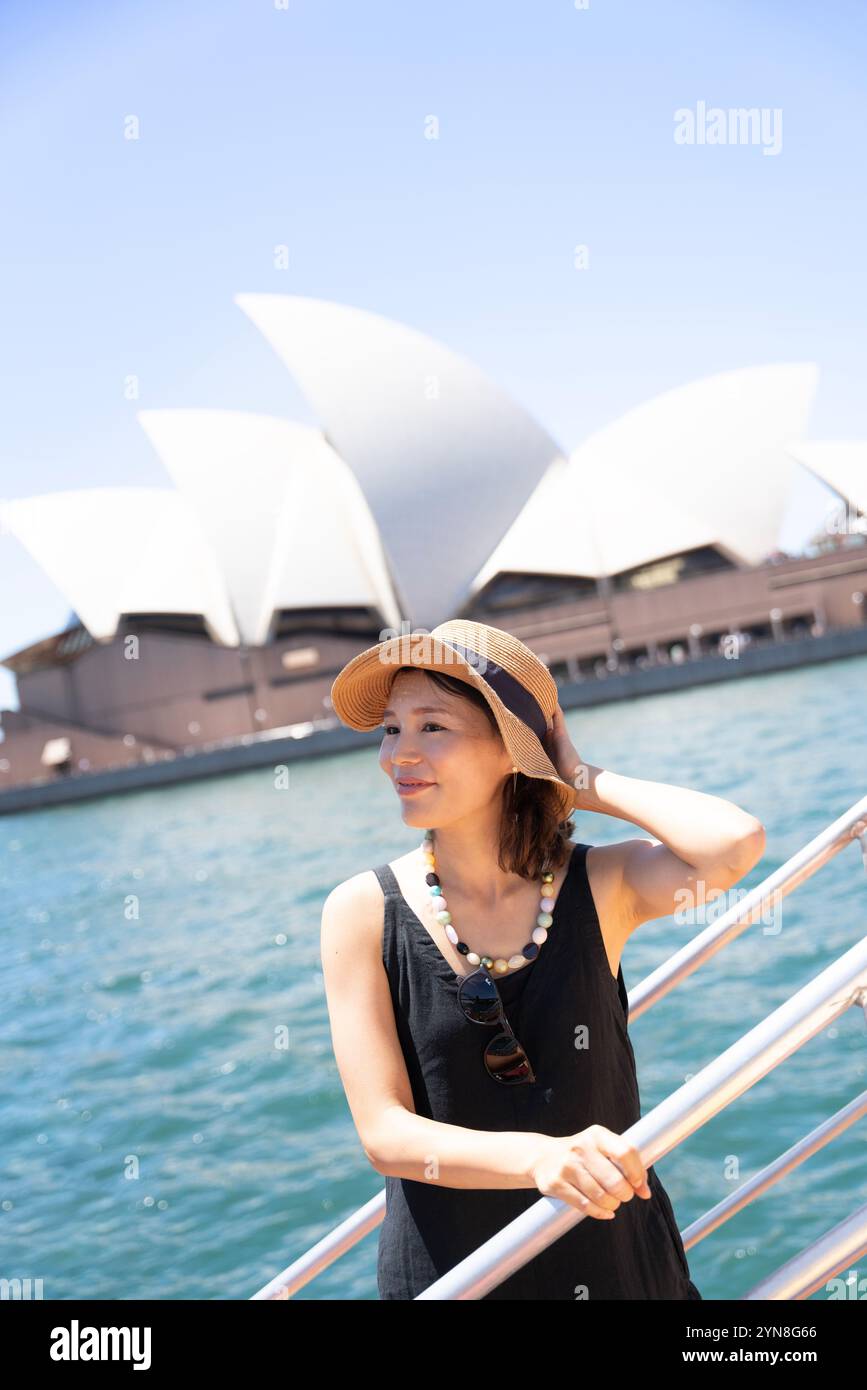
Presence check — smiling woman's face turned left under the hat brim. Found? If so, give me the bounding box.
[379,670,511,830]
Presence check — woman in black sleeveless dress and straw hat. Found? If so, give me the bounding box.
[322,620,764,1300]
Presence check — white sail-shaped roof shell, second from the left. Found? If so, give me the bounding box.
[138,410,400,645]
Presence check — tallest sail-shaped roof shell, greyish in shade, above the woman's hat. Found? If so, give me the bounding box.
[235,295,561,628]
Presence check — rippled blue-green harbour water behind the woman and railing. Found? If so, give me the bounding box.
[0,657,867,1300]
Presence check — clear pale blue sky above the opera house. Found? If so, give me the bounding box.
[0,0,867,708]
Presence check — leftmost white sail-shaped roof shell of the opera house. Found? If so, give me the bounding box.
[3,488,238,645]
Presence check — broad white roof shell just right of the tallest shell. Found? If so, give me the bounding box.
[472,364,817,592]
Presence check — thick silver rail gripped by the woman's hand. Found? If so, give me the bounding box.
[417,937,867,1301]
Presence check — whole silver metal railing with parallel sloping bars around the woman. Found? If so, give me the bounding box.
[253,796,867,1300]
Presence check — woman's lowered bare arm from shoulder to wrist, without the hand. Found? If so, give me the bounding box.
[321,870,552,1187]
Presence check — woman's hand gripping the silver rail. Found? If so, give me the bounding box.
[531,1125,653,1220]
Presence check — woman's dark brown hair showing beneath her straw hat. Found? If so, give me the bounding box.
[395,666,575,878]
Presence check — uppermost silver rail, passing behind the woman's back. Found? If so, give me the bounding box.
[251,796,867,1300]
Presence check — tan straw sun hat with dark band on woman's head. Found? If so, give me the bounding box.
[331,619,578,820]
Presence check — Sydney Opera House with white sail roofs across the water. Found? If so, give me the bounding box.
[0,295,867,809]
